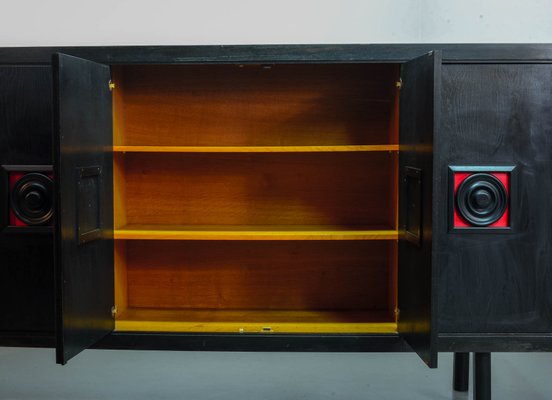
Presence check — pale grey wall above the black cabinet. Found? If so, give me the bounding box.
[0,0,552,46]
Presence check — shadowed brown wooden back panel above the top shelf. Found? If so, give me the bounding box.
[114,64,399,146]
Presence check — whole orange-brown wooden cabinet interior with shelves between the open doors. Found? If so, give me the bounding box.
[113,64,399,333]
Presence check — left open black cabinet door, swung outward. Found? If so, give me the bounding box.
[53,54,114,364]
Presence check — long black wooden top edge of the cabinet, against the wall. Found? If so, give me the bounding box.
[0,43,552,64]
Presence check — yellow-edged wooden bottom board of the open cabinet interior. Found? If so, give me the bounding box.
[115,308,397,334]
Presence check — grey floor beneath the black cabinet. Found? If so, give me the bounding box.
[0,348,552,400]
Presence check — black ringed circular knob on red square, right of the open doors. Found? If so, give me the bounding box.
[456,173,508,226]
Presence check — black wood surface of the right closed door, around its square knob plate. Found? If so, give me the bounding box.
[433,64,552,334]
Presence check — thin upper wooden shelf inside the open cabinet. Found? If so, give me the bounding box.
[113,144,399,153]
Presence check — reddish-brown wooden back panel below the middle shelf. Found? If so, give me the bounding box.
[127,241,394,312]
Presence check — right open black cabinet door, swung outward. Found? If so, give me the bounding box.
[398,52,441,368]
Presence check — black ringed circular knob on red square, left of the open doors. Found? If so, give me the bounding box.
[11,172,54,225]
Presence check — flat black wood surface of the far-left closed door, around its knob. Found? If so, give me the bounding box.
[0,66,55,343]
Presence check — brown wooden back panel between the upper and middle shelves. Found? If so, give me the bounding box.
[118,153,397,228]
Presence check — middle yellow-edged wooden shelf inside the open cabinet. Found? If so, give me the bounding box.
[114,225,398,240]
